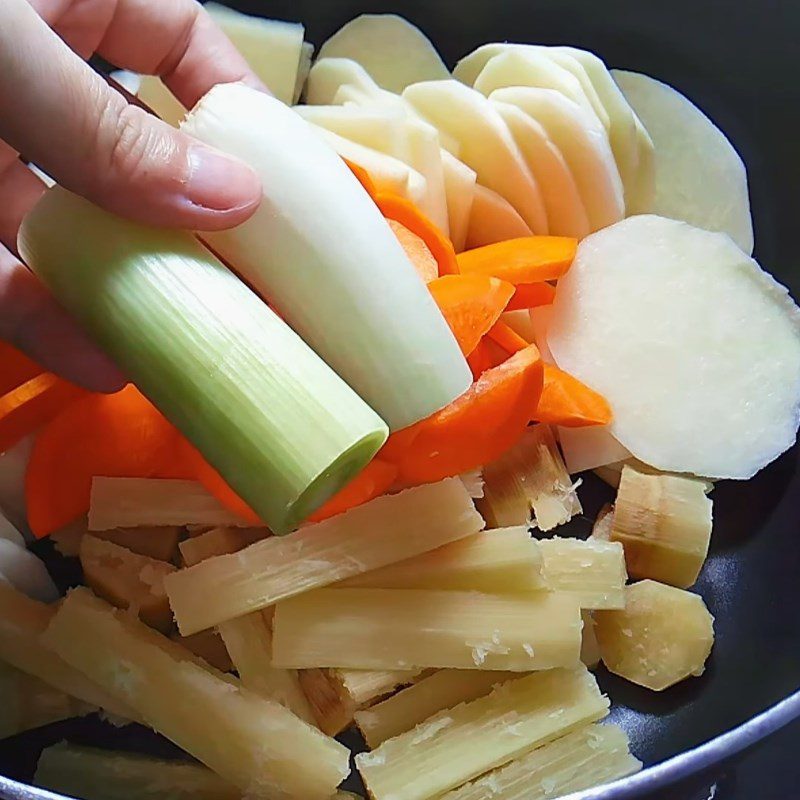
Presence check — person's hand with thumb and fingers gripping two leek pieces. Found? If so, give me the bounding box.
[0,0,265,392]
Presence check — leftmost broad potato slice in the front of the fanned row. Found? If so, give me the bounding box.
[403,80,548,233]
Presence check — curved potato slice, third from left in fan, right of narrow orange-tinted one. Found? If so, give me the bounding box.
[491,87,625,231]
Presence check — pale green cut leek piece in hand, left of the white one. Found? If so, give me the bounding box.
[19,189,388,532]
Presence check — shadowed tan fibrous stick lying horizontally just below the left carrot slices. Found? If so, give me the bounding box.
[89,477,248,531]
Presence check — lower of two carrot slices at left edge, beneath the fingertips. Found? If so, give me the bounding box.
[0,372,85,453]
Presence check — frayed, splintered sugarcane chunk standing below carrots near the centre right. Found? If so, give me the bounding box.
[478,425,581,531]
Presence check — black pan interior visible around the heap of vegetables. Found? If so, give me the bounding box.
[0,0,800,797]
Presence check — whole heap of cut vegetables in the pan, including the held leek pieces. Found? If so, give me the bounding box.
[0,4,800,800]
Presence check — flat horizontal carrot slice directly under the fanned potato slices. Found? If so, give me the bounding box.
[458,236,578,286]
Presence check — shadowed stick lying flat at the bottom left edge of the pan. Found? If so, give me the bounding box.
[33,742,242,800]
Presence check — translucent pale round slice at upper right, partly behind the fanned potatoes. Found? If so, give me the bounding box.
[612,70,753,253]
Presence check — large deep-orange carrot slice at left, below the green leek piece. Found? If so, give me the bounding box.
[25,386,192,537]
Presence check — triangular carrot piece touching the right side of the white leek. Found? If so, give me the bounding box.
[428,275,514,356]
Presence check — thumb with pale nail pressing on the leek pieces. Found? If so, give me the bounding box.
[0,0,261,230]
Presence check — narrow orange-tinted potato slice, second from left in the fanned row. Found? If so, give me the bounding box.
[492,100,589,239]
